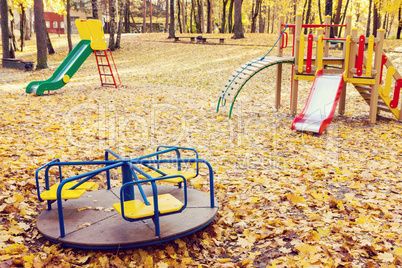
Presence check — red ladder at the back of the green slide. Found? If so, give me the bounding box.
[94,48,121,88]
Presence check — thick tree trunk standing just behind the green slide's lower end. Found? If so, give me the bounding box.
[34,0,48,69]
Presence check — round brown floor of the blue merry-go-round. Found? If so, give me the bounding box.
[37,185,218,249]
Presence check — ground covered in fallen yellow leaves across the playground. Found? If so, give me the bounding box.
[0,34,402,268]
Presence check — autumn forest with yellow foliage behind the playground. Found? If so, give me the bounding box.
[0,0,402,68]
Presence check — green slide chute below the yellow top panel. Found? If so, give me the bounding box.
[26,40,93,95]
